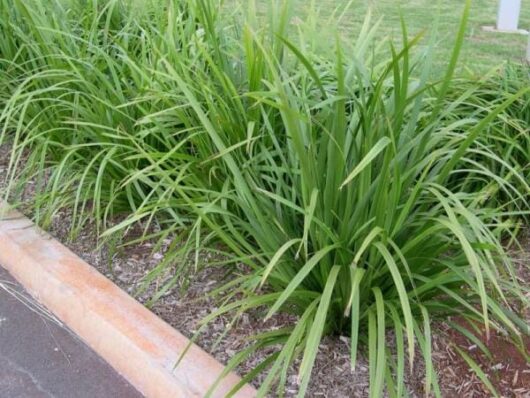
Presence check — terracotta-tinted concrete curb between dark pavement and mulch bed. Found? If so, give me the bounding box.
[0,201,256,398]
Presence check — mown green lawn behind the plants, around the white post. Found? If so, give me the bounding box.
[238,0,530,72]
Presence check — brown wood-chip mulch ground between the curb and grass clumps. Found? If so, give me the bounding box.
[0,141,530,398]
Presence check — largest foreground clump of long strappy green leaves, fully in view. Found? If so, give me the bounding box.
[164,8,528,397]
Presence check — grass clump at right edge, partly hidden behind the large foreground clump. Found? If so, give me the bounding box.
[446,64,530,225]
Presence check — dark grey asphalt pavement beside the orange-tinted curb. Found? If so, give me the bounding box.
[0,267,142,398]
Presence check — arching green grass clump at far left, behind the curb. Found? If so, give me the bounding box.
[0,0,207,237]
